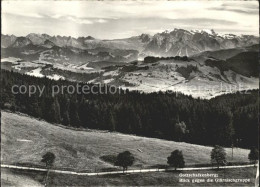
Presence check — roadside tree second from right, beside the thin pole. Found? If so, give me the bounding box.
[210,145,227,168]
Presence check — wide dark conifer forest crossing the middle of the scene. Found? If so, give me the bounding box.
[0,70,258,148]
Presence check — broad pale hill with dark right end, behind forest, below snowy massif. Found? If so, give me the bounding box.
[91,51,259,99]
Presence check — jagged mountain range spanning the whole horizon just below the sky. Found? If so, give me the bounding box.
[1,29,258,57]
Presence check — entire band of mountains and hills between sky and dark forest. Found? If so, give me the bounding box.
[1,29,259,98]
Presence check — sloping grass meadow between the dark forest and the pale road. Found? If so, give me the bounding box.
[1,111,249,172]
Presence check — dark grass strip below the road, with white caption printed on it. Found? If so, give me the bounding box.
[2,168,256,186]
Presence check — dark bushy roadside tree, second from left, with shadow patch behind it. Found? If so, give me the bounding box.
[115,151,135,172]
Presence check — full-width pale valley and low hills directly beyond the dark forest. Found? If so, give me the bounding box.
[1,46,259,99]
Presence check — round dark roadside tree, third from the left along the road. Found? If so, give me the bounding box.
[167,149,185,170]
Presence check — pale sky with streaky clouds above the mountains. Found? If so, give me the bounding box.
[2,0,259,39]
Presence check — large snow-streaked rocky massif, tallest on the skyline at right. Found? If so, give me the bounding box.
[144,28,258,57]
